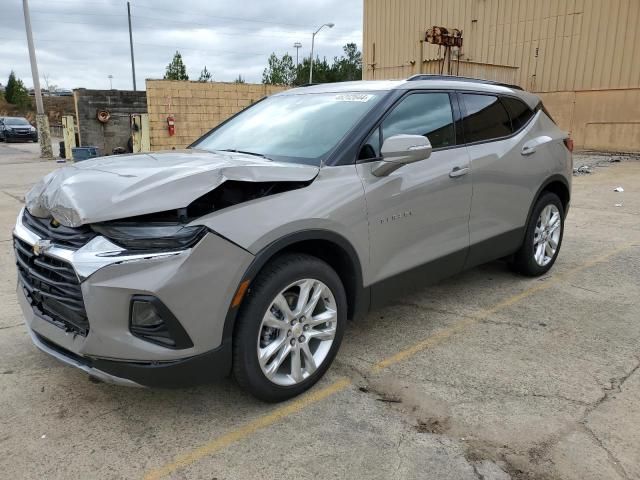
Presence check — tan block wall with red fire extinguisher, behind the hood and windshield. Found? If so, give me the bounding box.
[146,80,286,150]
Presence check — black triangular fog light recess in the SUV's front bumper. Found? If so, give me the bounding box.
[129,295,193,349]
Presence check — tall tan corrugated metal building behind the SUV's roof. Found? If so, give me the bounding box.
[363,0,640,151]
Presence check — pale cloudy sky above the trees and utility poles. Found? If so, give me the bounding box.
[0,0,362,89]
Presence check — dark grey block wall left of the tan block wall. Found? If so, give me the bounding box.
[73,88,147,155]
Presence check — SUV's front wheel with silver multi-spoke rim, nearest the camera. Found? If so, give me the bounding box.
[233,253,347,402]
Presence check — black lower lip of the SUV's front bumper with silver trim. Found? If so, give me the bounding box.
[27,320,231,388]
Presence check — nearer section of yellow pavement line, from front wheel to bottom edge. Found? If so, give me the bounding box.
[144,378,351,480]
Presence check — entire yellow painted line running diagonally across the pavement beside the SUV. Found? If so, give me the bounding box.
[144,244,634,480]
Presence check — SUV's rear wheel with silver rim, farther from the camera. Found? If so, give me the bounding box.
[512,192,564,277]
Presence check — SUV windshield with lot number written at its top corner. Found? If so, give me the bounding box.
[192,92,382,165]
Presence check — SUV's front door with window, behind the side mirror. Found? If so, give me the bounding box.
[357,92,472,305]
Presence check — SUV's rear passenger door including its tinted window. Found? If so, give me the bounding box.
[459,93,546,267]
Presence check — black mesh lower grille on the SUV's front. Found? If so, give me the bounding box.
[13,237,89,336]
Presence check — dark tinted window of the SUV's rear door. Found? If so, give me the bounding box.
[462,93,511,143]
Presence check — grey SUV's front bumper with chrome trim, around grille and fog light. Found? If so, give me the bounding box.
[14,210,253,386]
